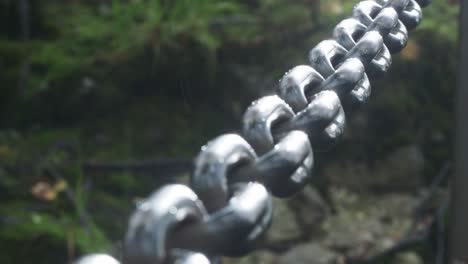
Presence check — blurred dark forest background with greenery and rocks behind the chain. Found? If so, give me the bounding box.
[0,0,458,264]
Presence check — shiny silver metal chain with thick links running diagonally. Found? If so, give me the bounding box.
[77,0,431,264]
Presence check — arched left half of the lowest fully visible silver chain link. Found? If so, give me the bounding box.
[124,184,206,264]
